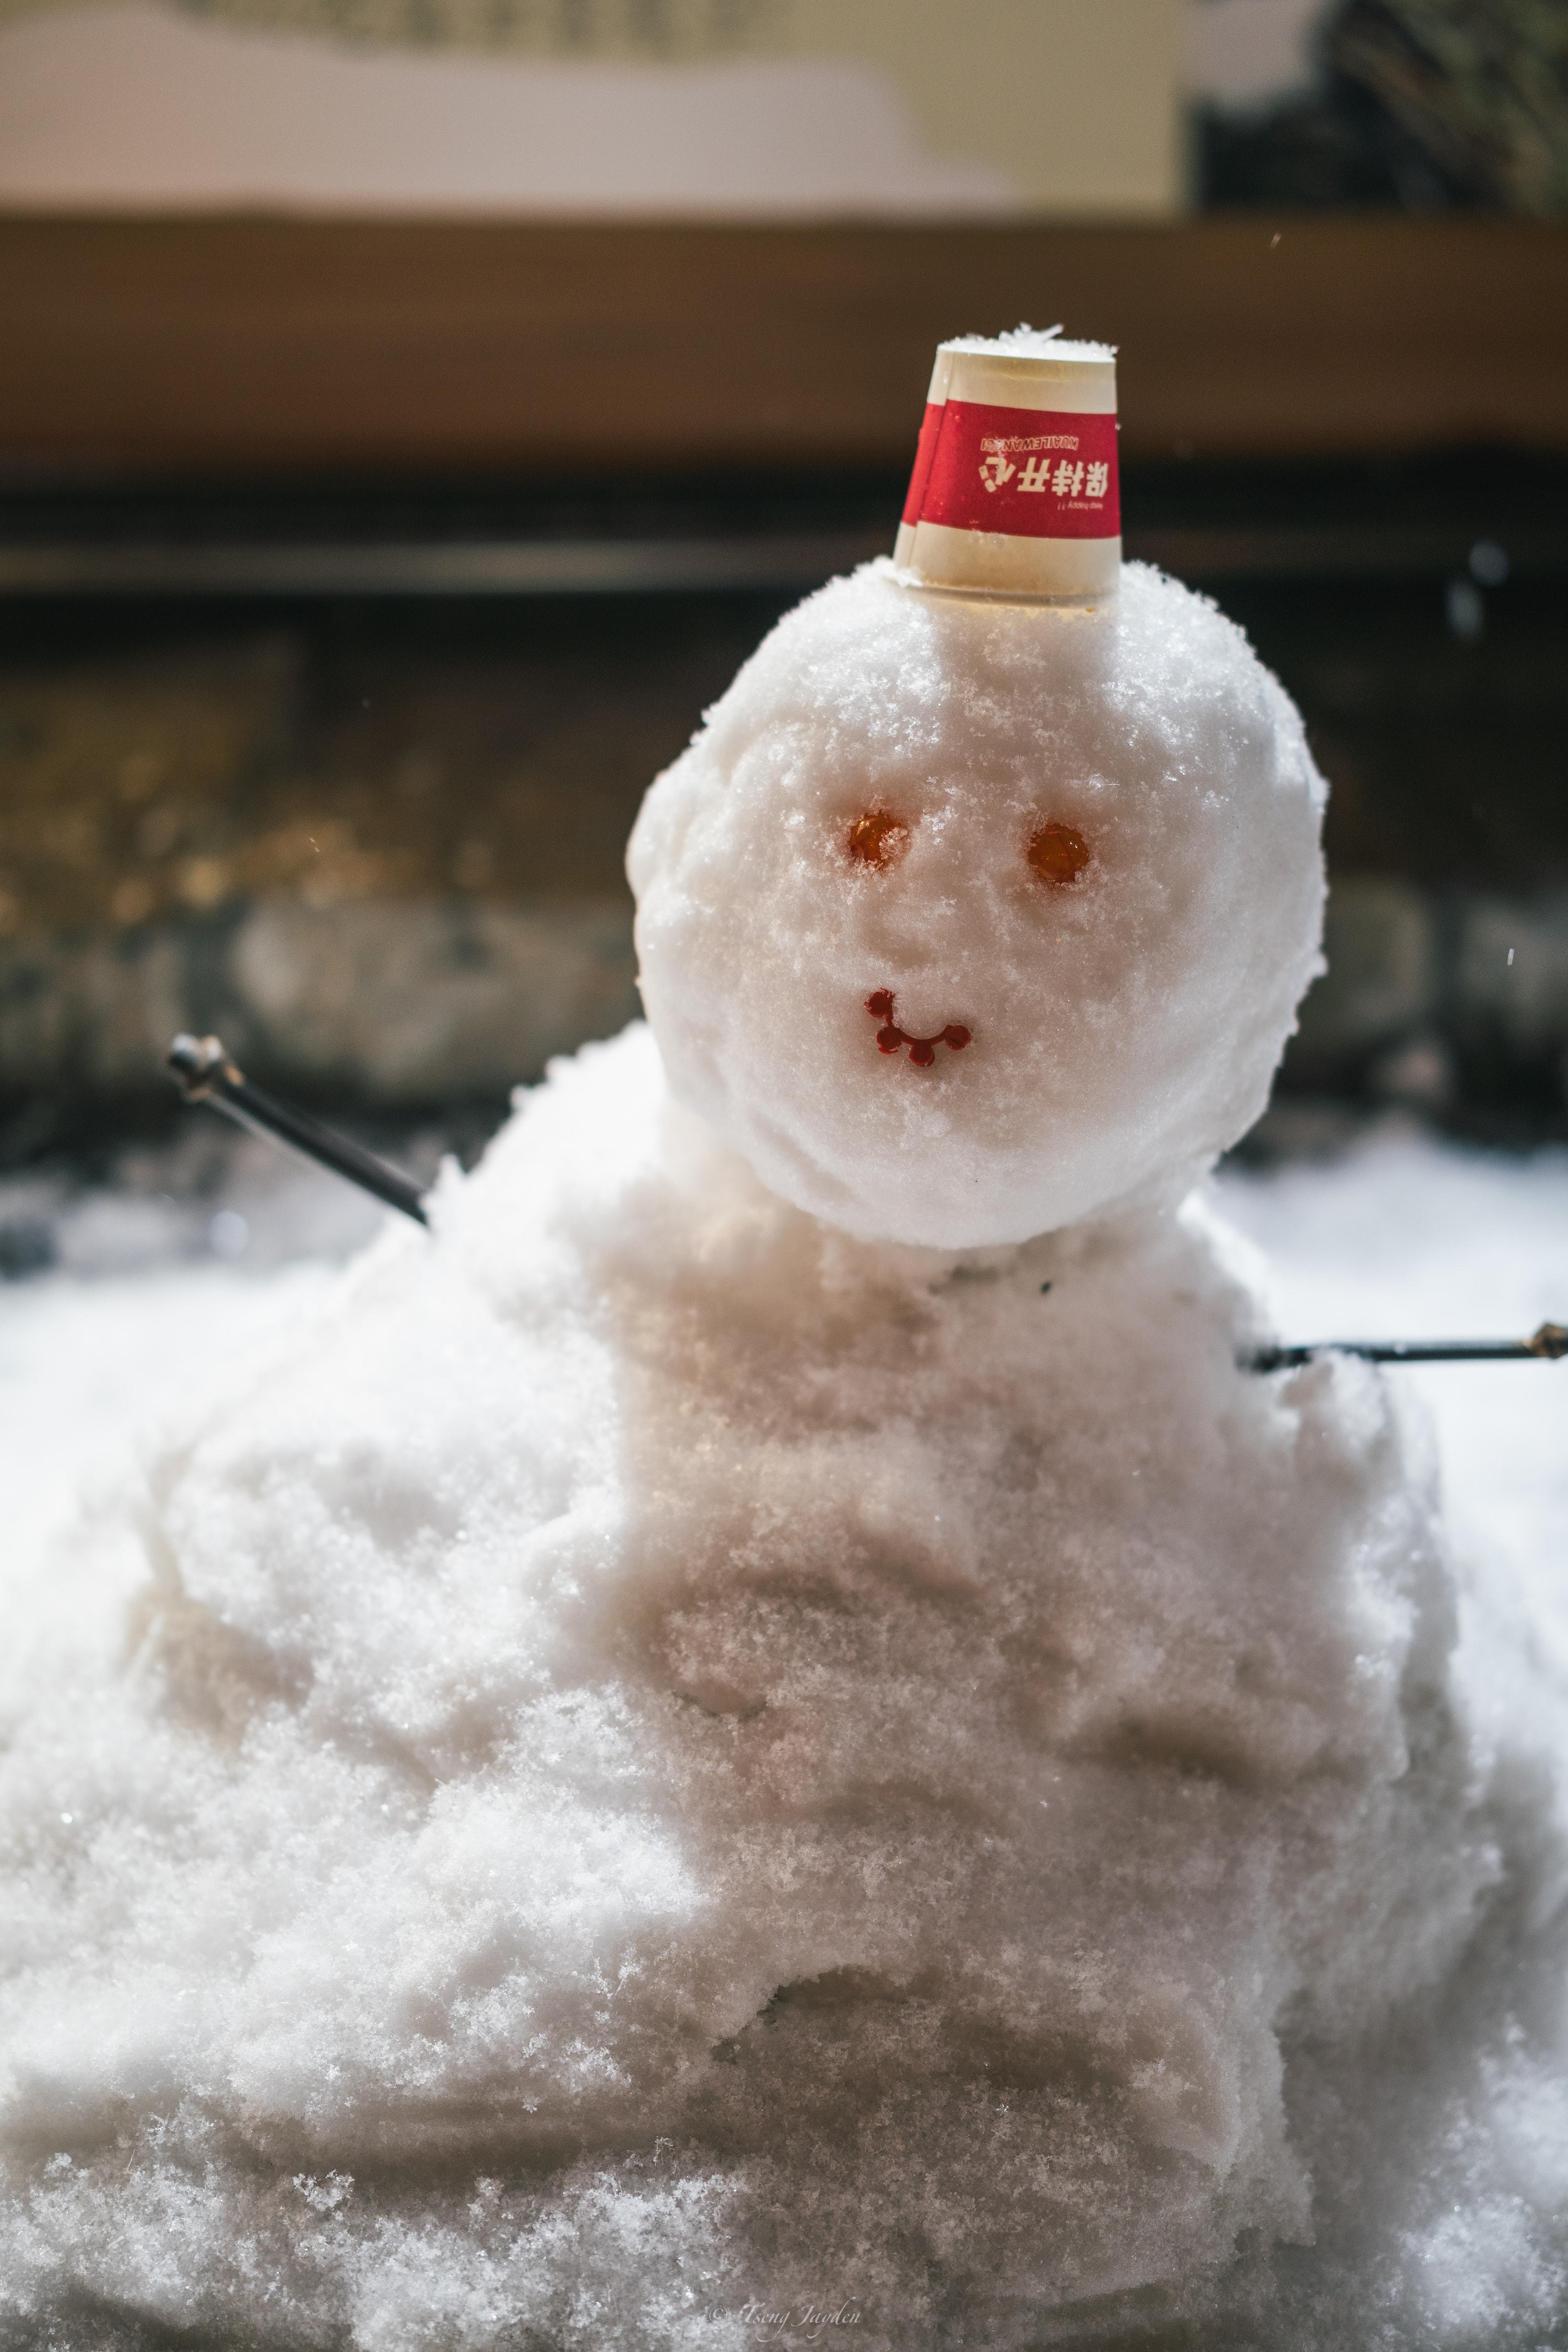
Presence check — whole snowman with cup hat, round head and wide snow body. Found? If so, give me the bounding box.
[0,334,1563,2352]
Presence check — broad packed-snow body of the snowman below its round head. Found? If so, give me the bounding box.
[0,1030,1566,2352]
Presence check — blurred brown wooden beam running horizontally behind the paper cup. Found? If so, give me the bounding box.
[0,214,1568,475]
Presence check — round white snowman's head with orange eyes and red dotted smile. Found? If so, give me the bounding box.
[628,562,1324,1249]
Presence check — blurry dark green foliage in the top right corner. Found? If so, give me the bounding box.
[1326,0,1568,214]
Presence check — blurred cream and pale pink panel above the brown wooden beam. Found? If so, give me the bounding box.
[0,0,1185,219]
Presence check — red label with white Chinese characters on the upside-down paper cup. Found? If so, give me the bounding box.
[903,400,1121,539]
